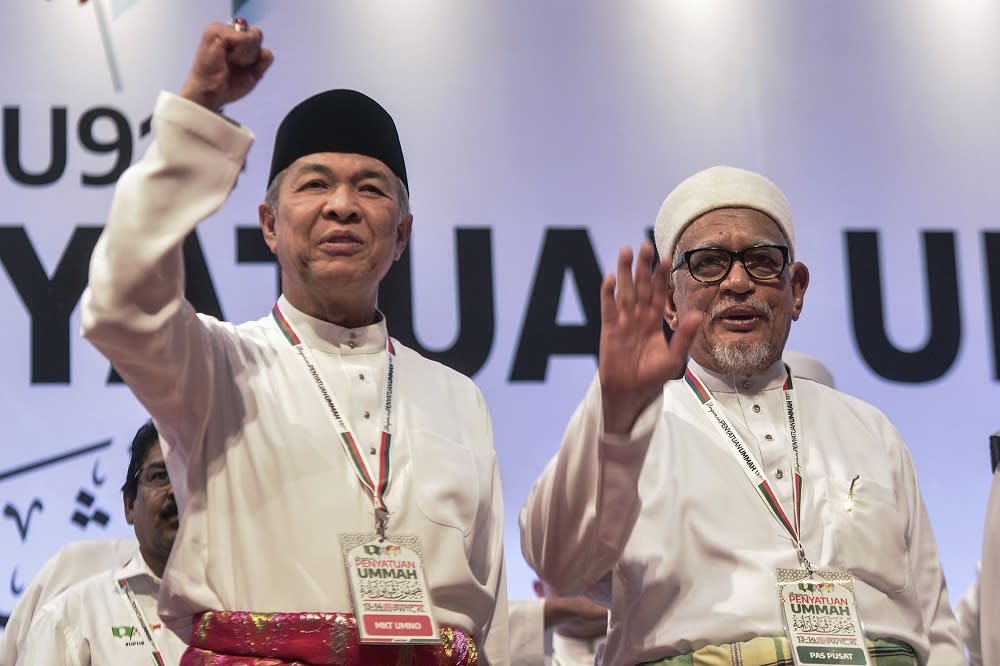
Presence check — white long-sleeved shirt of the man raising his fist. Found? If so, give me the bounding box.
[83,93,507,664]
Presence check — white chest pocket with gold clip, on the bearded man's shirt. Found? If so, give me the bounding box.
[825,477,910,596]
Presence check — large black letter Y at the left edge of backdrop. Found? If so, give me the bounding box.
[0,227,101,384]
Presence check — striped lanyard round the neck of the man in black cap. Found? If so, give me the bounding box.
[271,303,396,538]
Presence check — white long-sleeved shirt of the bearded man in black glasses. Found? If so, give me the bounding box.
[520,362,964,666]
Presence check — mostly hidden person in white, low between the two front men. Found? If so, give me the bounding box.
[509,580,608,666]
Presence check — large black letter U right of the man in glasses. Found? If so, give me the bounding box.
[846,231,962,384]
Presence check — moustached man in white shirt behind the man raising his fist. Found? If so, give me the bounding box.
[16,423,186,666]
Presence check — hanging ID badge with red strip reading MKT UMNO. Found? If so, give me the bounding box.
[340,534,441,644]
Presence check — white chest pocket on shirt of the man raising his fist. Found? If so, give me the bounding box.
[410,432,481,536]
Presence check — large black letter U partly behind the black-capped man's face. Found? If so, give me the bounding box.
[378,229,494,376]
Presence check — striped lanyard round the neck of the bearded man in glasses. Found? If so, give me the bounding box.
[684,364,812,573]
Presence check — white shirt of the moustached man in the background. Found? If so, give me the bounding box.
[17,554,186,666]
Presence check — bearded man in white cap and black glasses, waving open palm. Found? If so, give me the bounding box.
[520,167,964,666]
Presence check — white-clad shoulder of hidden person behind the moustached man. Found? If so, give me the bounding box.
[0,538,139,664]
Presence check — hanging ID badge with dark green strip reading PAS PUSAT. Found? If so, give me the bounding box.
[778,569,871,666]
